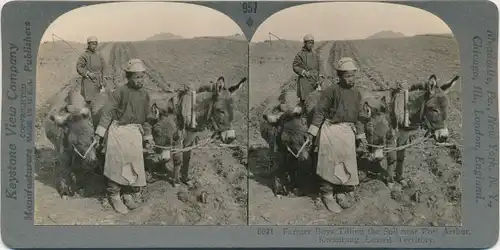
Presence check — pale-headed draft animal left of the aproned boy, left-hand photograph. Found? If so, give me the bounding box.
[44,91,108,198]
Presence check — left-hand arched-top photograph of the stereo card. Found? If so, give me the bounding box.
[34,2,248,225]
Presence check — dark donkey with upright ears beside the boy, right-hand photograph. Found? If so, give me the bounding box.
[360,74,459,188]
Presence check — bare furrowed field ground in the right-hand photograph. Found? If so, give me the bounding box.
[248,36,462,226]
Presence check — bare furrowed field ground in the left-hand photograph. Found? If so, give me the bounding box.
[35,38,248,225]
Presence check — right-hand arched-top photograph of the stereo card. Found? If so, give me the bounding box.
[248,3,463,227]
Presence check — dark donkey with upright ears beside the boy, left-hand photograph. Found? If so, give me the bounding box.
[152,76,247,186]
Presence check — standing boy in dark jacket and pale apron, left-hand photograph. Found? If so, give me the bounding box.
[95,59,154,214]
